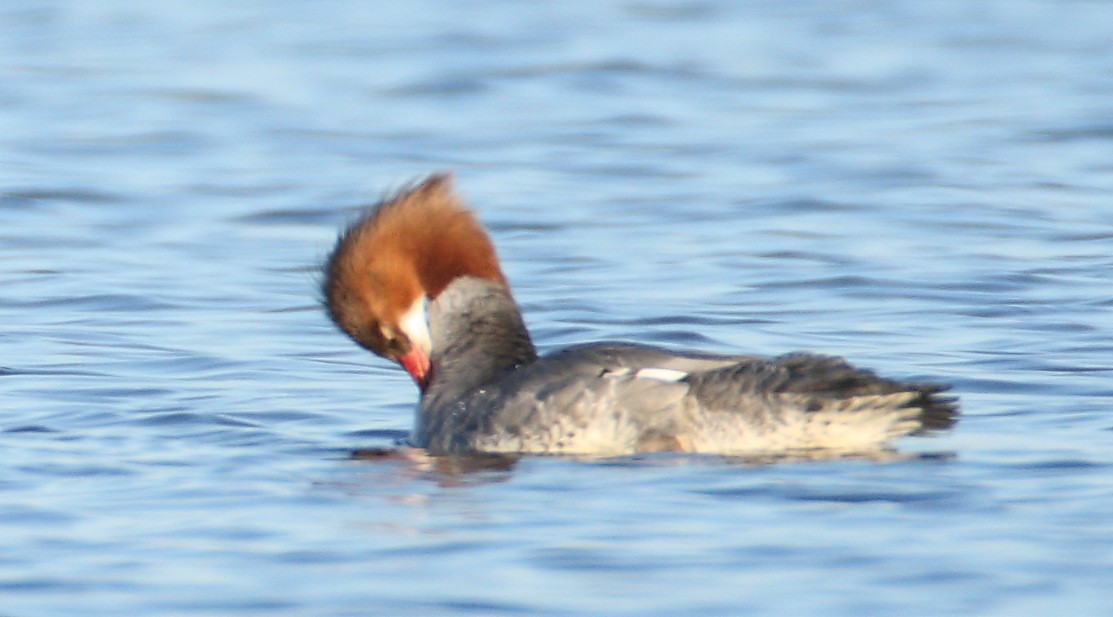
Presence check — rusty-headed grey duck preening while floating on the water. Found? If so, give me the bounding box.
[322,173,958,458]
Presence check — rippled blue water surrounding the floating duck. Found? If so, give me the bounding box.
[0,0,1113,617]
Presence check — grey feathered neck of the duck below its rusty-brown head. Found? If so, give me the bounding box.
[425,276,538,400]
